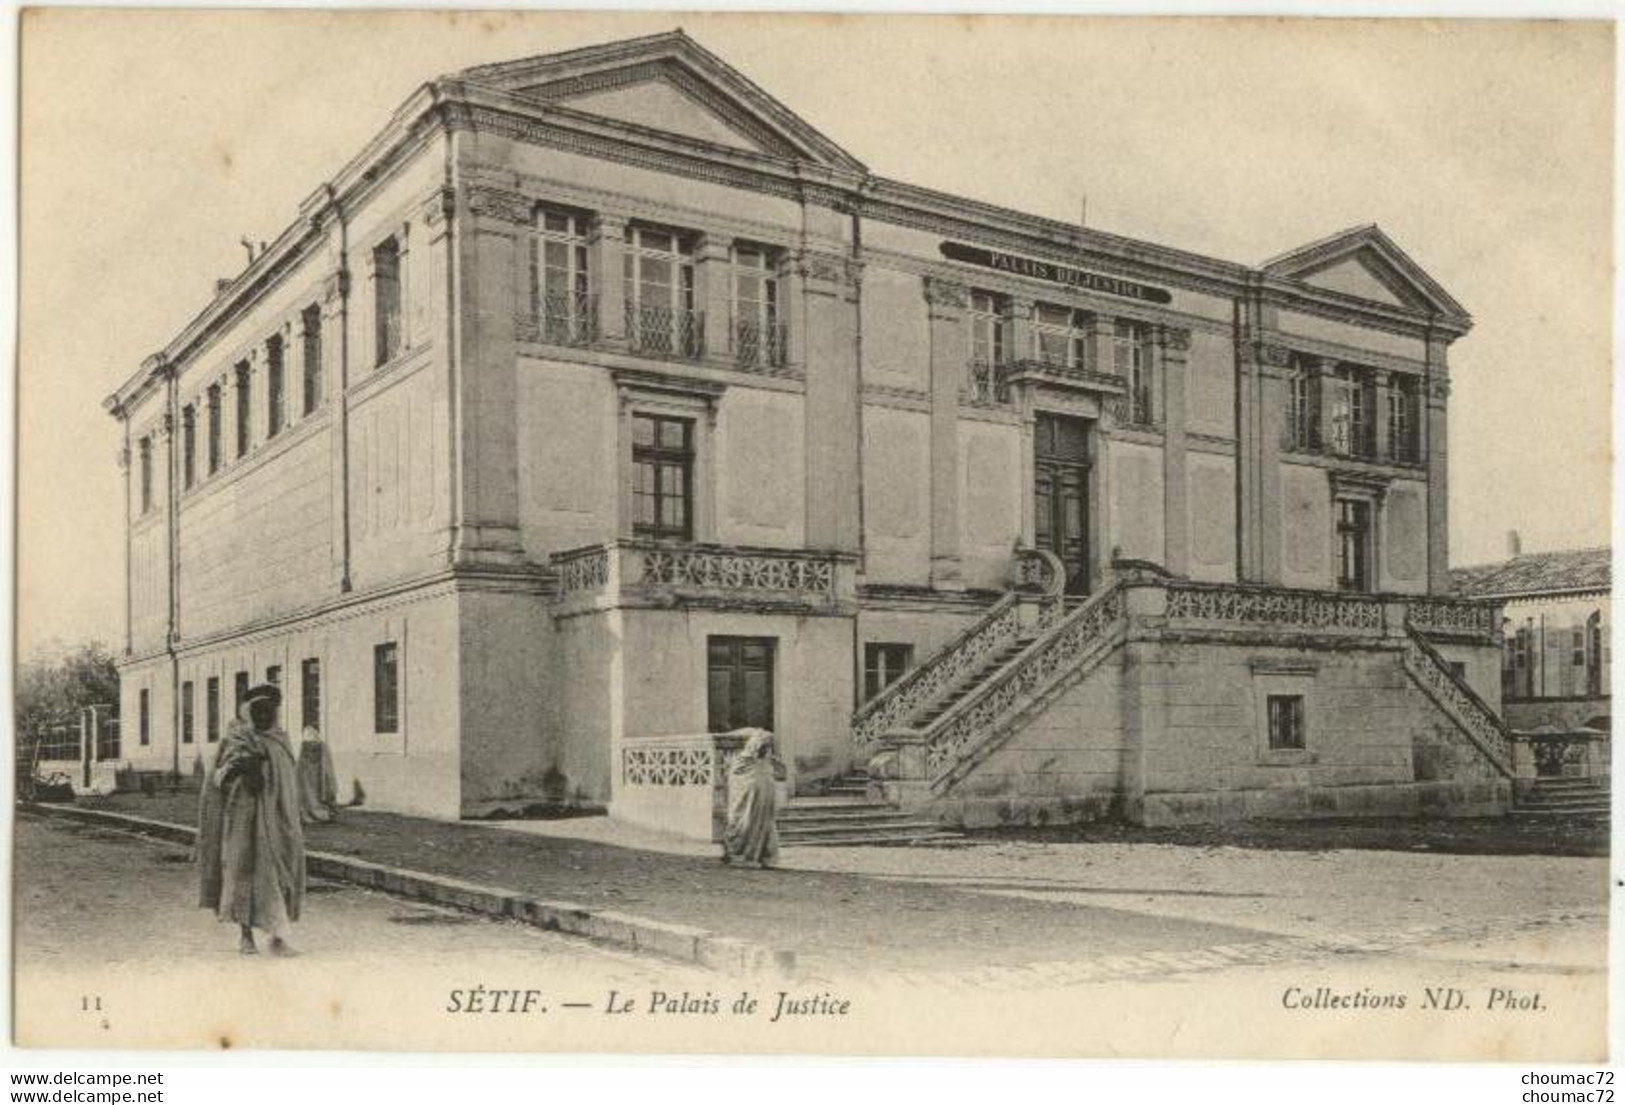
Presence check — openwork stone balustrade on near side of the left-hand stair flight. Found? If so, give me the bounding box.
[920,582,1128,785]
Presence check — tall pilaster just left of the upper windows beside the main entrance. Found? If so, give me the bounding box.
[923,276,970,590]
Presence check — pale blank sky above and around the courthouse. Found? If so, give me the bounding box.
[18,8,1614,658]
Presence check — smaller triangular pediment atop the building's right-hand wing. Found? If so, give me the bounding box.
[1263,226,1469,322]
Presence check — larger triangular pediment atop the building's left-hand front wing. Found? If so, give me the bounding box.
[458,31,865,172]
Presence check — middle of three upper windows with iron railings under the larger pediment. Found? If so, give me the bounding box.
[624,226,705,359]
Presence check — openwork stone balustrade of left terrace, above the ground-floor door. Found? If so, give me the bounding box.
[551,540,855,609]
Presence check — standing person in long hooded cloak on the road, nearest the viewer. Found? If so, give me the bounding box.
[198,683,306,956]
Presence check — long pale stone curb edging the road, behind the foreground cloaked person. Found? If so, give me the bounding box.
[24,804,796,975]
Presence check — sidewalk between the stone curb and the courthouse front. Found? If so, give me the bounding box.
[69,793,1274,977]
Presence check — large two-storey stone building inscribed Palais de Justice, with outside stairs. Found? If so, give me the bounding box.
[107,33,1508,826]
